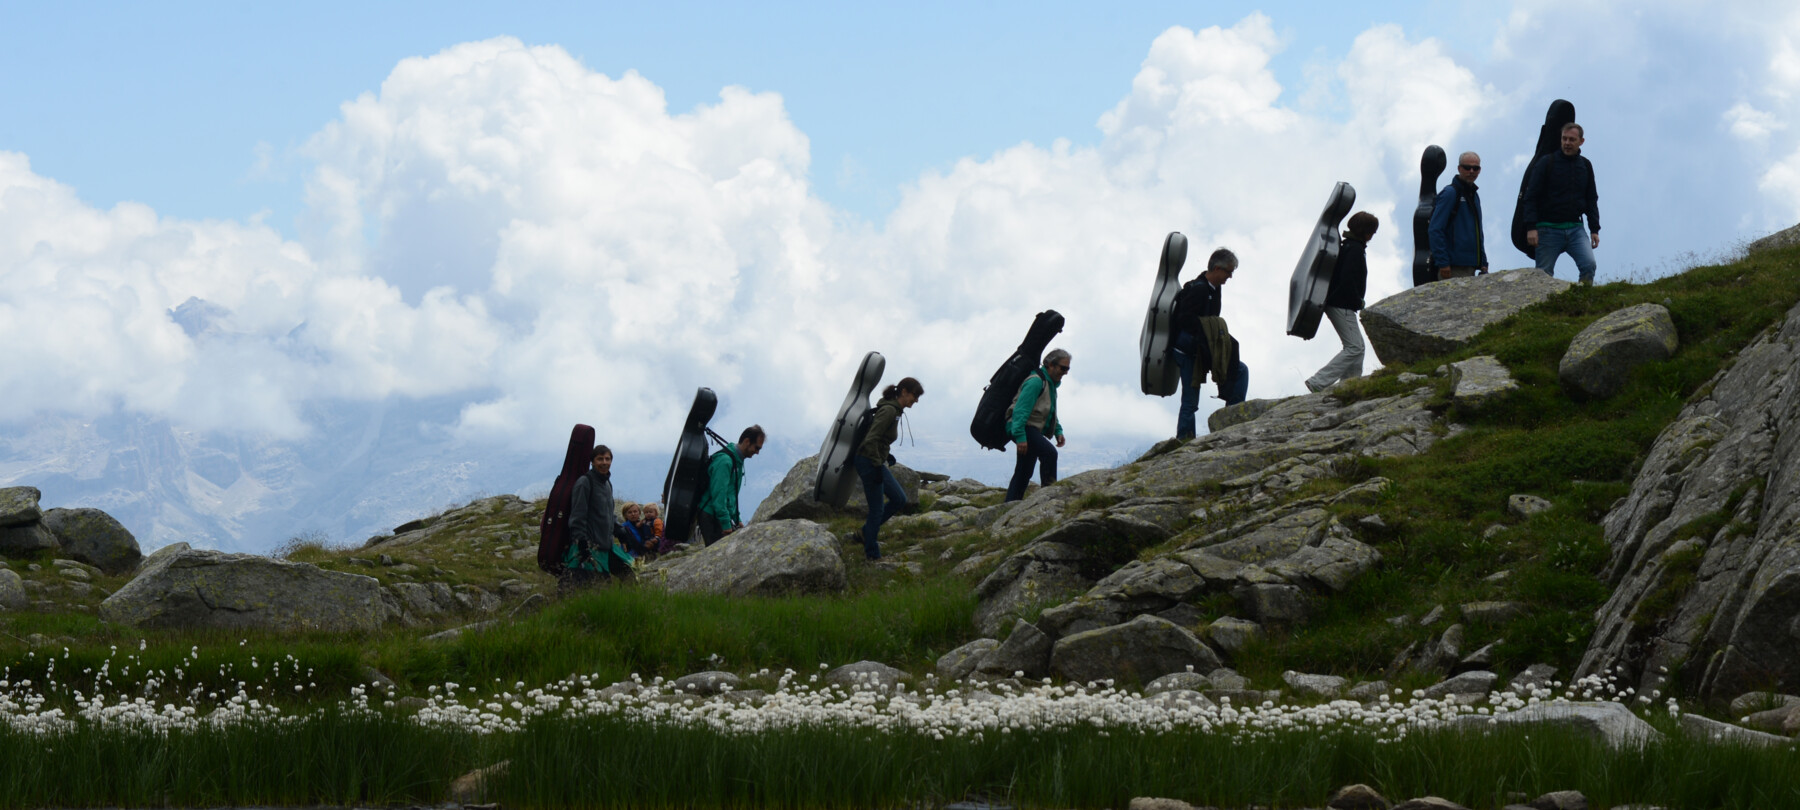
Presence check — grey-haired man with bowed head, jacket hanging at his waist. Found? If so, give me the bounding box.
[1174,248,1249,439]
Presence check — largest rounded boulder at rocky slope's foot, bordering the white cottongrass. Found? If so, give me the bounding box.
[1049,616,1224,684]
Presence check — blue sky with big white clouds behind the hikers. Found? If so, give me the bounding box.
[0,2,1800,525]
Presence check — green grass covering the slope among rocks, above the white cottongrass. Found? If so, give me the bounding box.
[0,248,1800,700]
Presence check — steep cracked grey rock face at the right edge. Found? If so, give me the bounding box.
[1575,293,1800,700]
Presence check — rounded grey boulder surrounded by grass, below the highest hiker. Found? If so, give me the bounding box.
[1557,304,1681,400]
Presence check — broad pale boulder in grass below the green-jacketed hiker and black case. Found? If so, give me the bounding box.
[641,520,848,596]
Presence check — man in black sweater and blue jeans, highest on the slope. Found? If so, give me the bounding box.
[1519,122,1600,284]
